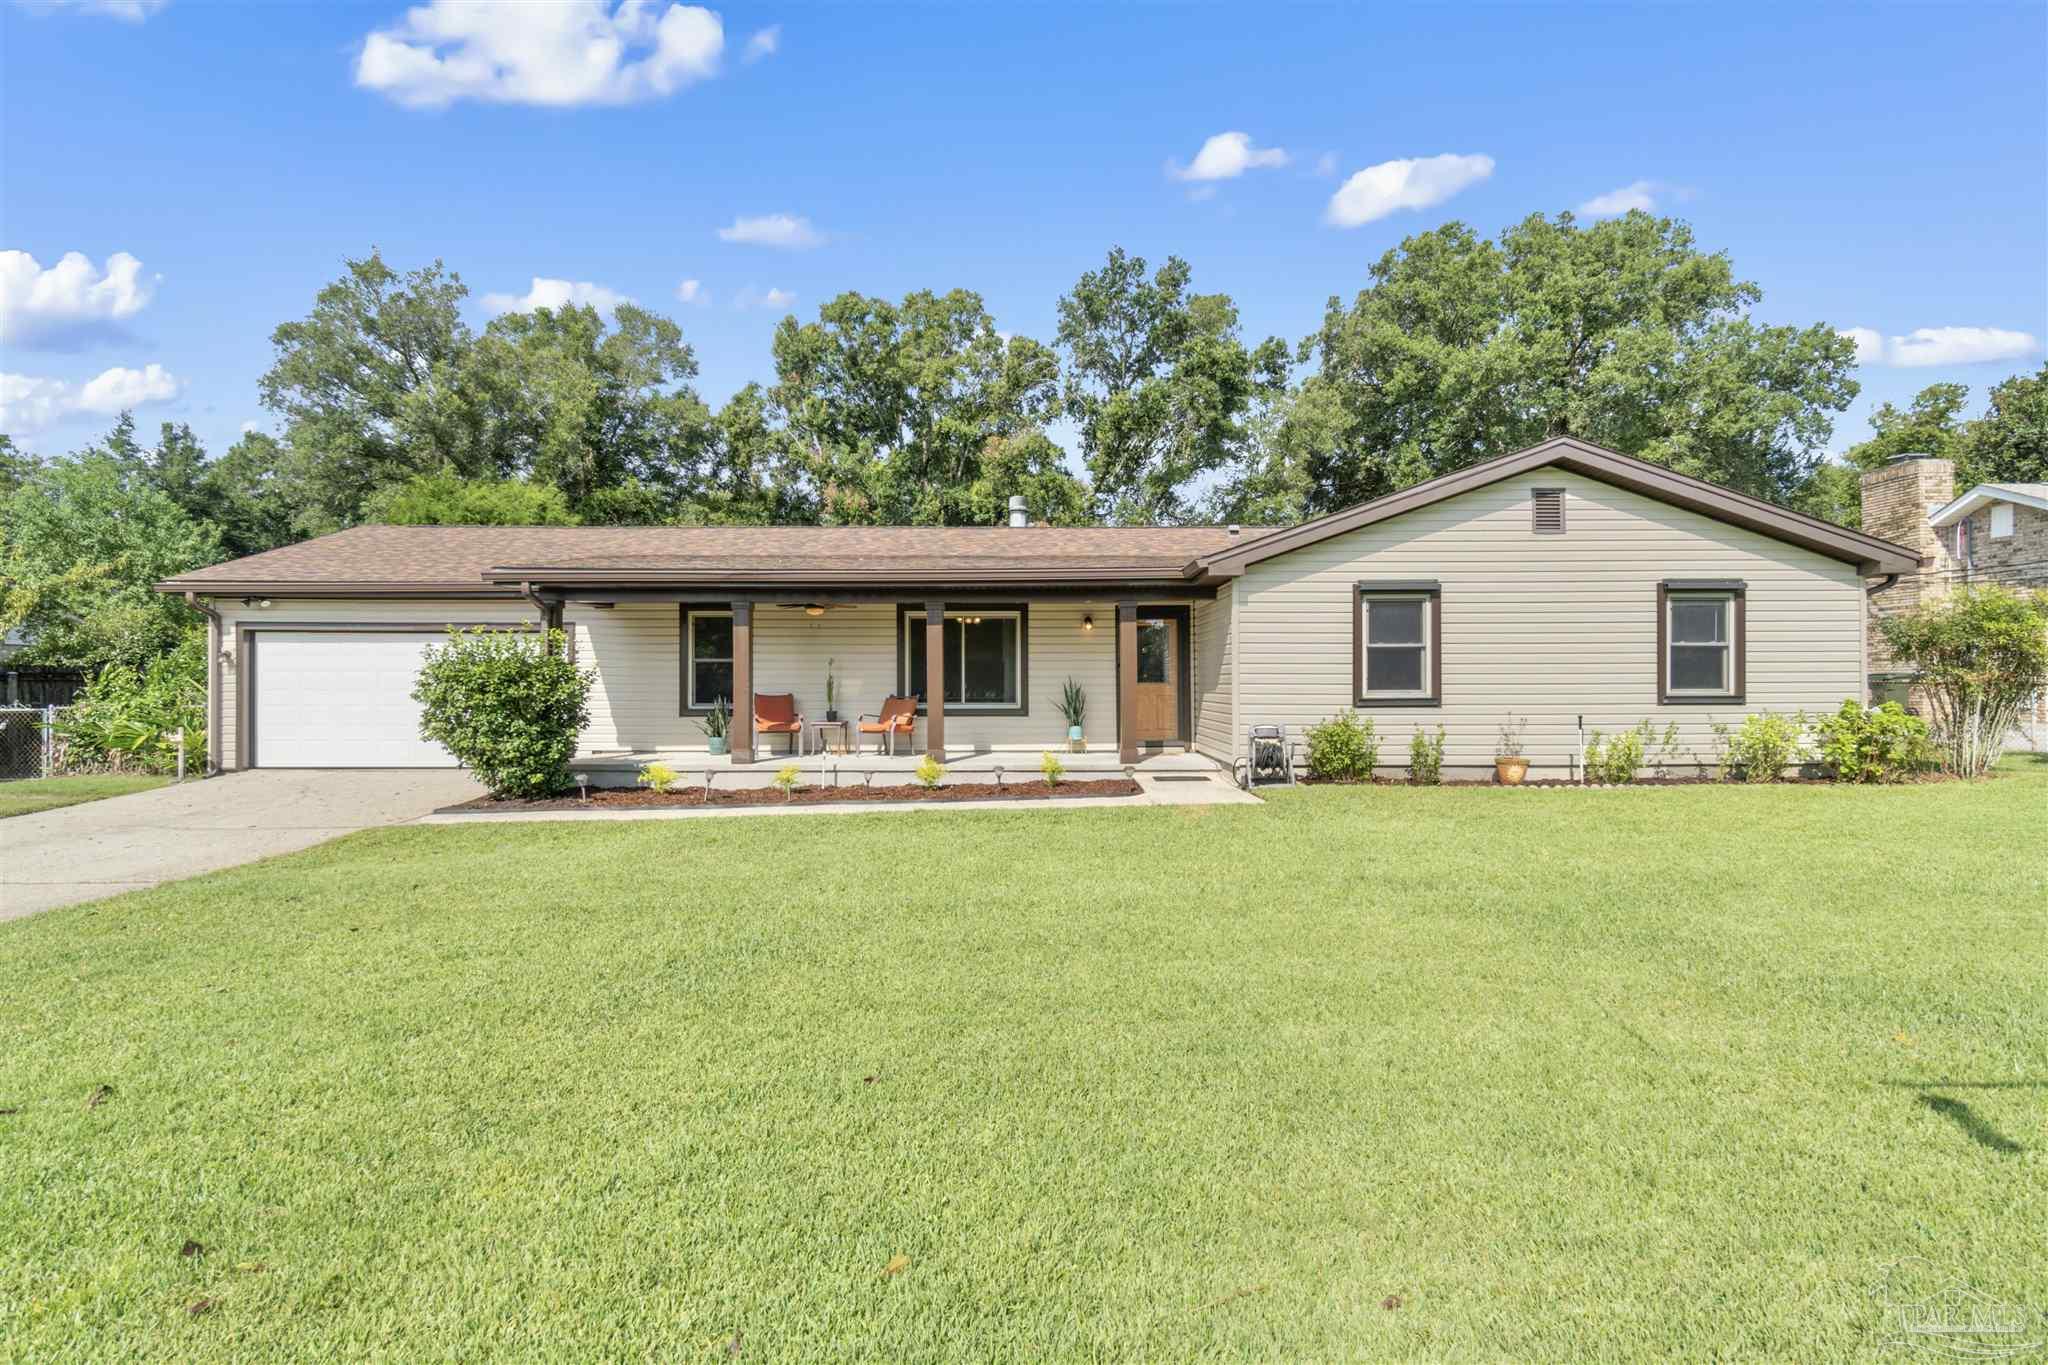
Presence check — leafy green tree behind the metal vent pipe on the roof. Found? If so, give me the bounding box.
[770,289,1083,526]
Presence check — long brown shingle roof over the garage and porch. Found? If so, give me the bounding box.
[164,526,1253,591]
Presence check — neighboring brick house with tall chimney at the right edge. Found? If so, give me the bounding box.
[1864,454,2048,749]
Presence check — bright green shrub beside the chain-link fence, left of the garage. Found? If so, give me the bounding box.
[57,630,207,772]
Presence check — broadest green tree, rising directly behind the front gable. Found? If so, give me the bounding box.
[1253,211,1858,512]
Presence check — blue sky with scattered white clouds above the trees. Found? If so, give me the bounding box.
[0,0,2048,470]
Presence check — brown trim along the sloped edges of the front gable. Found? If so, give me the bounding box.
[1188,436,1919,577]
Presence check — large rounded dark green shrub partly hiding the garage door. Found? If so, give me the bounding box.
[412,626,594,796]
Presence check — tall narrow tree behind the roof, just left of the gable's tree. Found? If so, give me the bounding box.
[1059,246,1288,522]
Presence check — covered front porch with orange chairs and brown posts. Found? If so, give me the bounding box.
[548,585,1214,786]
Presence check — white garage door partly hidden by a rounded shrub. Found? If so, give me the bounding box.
[252,630,457,767]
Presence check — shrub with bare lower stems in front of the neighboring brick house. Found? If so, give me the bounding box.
[1878,585,2048,778]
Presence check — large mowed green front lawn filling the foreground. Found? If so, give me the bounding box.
[0,763,2048,1361]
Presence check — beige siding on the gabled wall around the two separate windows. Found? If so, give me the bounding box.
[1233,469,1864,769]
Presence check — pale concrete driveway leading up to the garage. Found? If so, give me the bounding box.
[0,767,483,919]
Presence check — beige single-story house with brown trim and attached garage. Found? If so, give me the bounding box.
[160,438,1919,780]
